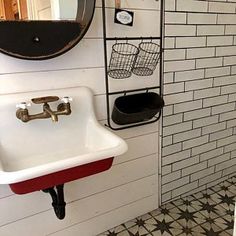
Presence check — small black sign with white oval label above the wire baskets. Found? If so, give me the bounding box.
[115,9,134,26]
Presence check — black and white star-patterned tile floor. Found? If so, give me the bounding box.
[98,177,236,236]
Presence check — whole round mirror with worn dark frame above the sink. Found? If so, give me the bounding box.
[0,0,96,60]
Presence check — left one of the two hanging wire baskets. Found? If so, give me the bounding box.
[108,43,139,79]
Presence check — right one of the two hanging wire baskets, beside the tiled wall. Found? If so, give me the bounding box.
[132,42,160,76]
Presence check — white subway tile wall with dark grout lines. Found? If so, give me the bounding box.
[161,0,236,202]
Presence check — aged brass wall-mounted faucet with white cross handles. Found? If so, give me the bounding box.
[16,96,72,122]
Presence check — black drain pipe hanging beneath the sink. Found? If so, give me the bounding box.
[42,184,66,220]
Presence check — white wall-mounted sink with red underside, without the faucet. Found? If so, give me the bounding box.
[0,87,127,194]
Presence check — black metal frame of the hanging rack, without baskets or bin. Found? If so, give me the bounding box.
[102,0,164,130]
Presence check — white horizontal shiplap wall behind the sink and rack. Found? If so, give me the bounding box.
[0,0,159,236]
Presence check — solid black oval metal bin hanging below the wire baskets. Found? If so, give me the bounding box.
[112,92,164,125]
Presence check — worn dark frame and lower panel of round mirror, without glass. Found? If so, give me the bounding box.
[0,0,96,60]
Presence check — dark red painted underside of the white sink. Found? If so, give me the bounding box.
[10,157,113,194]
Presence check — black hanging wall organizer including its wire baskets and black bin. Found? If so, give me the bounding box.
[102,0,164,130]
